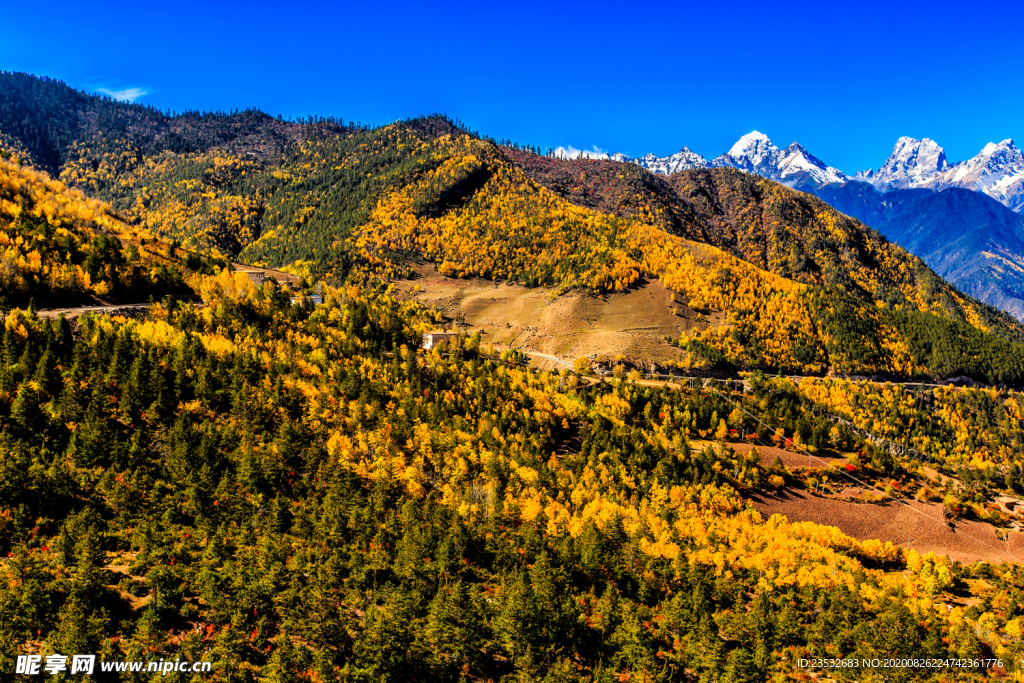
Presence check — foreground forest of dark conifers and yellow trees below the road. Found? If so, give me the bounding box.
[0,276,1024,681]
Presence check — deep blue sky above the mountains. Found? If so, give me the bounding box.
[0,0,1024,172]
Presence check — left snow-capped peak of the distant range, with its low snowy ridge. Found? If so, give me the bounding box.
[611,131,850,186]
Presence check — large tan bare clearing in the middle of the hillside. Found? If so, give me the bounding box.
[395,263,719,364]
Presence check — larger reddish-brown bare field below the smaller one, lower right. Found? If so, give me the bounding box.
[751,488,1024,563]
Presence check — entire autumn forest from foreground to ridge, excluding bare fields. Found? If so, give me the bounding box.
[6,75,1024,683]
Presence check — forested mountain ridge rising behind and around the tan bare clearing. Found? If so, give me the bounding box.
[6,75,1024,383]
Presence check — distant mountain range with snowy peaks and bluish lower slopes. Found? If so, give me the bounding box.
[611,131,1024,319]
